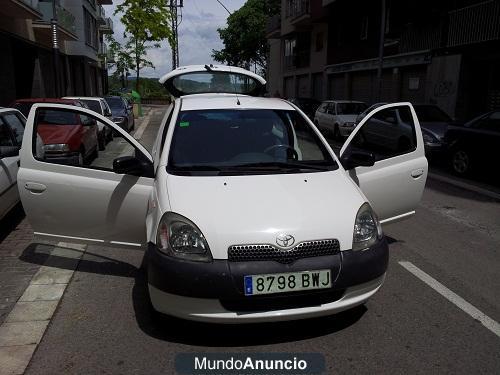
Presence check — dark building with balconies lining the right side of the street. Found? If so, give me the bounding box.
[268,0,500,119]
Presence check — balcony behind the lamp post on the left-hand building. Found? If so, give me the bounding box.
[33,1,78,46]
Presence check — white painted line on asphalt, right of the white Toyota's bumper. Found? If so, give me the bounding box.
[398,261,500,337]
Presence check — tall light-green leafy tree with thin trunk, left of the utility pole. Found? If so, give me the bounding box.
[114,0,174,91]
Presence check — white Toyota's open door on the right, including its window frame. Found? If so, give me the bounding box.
[340,103,428,223]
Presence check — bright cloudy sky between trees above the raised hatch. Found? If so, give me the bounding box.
[104,0,245,78]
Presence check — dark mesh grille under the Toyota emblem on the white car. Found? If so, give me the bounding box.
[228,239,340,264]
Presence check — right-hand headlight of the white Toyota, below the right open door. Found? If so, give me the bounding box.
[352,203,383,251]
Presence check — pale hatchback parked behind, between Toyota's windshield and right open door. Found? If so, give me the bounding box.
[314,100,367,139]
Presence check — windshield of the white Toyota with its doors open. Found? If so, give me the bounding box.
[167,109,338,175]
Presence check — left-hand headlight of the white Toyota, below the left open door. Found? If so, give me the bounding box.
[156,212,212,262]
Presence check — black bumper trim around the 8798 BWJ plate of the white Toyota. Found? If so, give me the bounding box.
[147,239,389,307]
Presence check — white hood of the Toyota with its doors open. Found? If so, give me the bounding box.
[167,170,364,259]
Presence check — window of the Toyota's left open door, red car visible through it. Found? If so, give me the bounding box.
[33,108,147,171]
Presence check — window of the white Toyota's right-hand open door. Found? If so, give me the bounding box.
[345,106,417,161]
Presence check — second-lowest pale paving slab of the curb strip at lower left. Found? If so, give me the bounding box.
[0,320,49,347]
